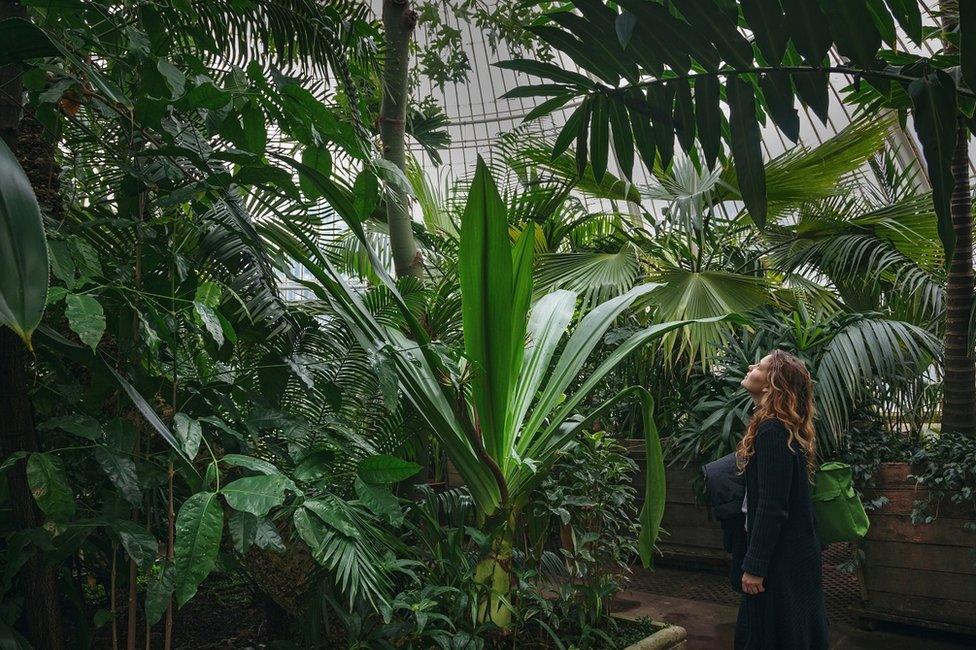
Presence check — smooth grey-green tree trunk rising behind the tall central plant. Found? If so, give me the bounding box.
[379,0,424,278]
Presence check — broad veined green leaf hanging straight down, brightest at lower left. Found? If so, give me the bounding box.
[174,492,224,607]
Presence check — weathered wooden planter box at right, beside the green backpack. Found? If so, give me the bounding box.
[859,463,976,634]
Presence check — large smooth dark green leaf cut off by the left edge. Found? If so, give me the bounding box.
[0,135,48,348]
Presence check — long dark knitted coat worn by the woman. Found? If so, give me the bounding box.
[726,420,827,650]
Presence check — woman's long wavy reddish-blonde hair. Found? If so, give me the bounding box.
[735,350,817,479]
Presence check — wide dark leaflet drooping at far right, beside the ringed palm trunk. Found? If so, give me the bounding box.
[908,70,957,268]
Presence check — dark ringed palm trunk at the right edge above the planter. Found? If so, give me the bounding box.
[942,120,976,436]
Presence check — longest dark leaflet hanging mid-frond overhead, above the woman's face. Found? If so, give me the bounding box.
[726,75,767,229]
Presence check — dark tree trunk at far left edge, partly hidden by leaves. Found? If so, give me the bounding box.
[0,0,64,650]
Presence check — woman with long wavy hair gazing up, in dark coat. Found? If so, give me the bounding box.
[733,350,827,650]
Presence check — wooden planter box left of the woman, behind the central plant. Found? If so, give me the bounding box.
[622,438,731,571]
